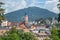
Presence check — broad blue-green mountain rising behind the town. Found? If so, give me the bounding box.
[5,7,57,22]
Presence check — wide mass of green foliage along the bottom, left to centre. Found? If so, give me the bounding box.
[1,27,37,40]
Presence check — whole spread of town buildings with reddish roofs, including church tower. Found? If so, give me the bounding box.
[0,13,56,40]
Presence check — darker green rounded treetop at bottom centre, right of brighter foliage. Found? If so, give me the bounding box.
[20,32,37,40]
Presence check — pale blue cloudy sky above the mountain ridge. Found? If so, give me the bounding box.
[0,0,58,14]
